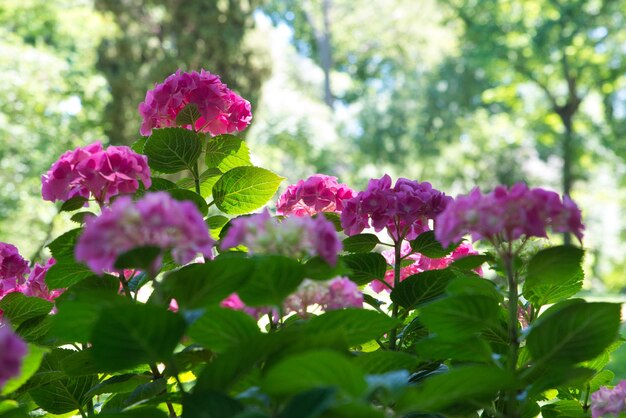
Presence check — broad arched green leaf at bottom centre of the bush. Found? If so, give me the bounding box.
[261,350,367,397]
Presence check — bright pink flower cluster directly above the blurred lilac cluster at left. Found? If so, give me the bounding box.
[41,142,152,205]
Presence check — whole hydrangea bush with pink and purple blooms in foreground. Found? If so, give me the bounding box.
[0,70,626,418]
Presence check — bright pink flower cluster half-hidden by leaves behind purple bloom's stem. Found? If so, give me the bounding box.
[370,241,482,293]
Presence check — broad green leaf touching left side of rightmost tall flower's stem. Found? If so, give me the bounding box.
[420,295,500,341]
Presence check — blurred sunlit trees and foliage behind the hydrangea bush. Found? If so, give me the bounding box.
[0,0,626,292]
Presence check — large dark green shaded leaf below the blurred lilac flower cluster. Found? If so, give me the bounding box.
[91,304,185,371]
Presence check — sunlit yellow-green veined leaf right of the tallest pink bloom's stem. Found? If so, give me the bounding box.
[213,167,283,215]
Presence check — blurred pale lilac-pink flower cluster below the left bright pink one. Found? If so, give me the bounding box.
[75,192,214,274]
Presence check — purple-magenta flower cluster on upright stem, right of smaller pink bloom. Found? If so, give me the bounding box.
[341,174,452,241]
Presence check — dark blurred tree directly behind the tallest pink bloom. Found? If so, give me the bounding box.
[96,0,271,144]
